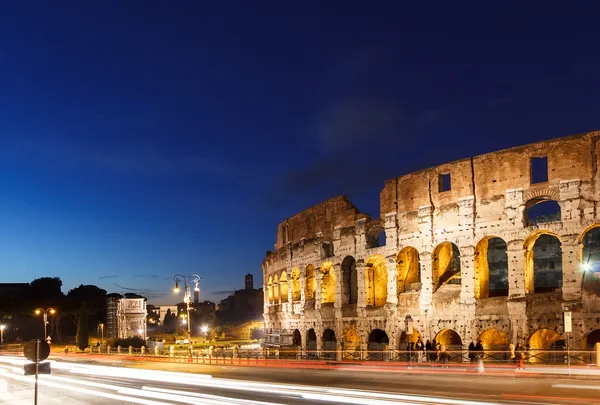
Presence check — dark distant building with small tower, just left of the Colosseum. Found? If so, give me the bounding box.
[217,274,264,323]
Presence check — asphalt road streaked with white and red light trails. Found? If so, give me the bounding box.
[0,357,600,405]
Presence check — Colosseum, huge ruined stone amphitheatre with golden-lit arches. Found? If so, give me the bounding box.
[262,131,600,359]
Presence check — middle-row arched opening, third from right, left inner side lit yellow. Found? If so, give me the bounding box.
[474,236,508,299]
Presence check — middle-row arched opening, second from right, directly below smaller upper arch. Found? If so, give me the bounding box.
[525,232,562,293]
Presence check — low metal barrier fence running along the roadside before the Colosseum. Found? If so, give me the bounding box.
[90,346,600,367]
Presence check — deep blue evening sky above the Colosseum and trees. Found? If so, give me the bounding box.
[0,1,600,303]
